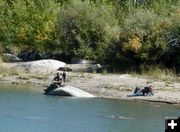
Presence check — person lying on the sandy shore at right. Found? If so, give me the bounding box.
[127,85,154,97]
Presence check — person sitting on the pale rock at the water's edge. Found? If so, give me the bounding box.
[44,72,64,93]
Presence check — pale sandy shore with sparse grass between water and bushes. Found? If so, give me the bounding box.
[0,72,180,104]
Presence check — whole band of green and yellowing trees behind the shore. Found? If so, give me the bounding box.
[0,0,180,72]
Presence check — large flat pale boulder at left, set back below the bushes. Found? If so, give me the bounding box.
[14,59,66,73]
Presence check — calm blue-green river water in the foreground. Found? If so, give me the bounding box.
[0,85,180,132]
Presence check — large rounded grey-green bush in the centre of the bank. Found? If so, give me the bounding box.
[58,0,118,60]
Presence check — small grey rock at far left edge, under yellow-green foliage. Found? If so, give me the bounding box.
[2,53,22,62]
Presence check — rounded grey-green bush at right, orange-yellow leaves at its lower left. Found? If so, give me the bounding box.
[124,9,171,63]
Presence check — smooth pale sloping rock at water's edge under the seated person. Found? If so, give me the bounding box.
[47,86,95,97]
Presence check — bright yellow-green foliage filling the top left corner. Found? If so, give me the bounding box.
[0,0,59,48]
